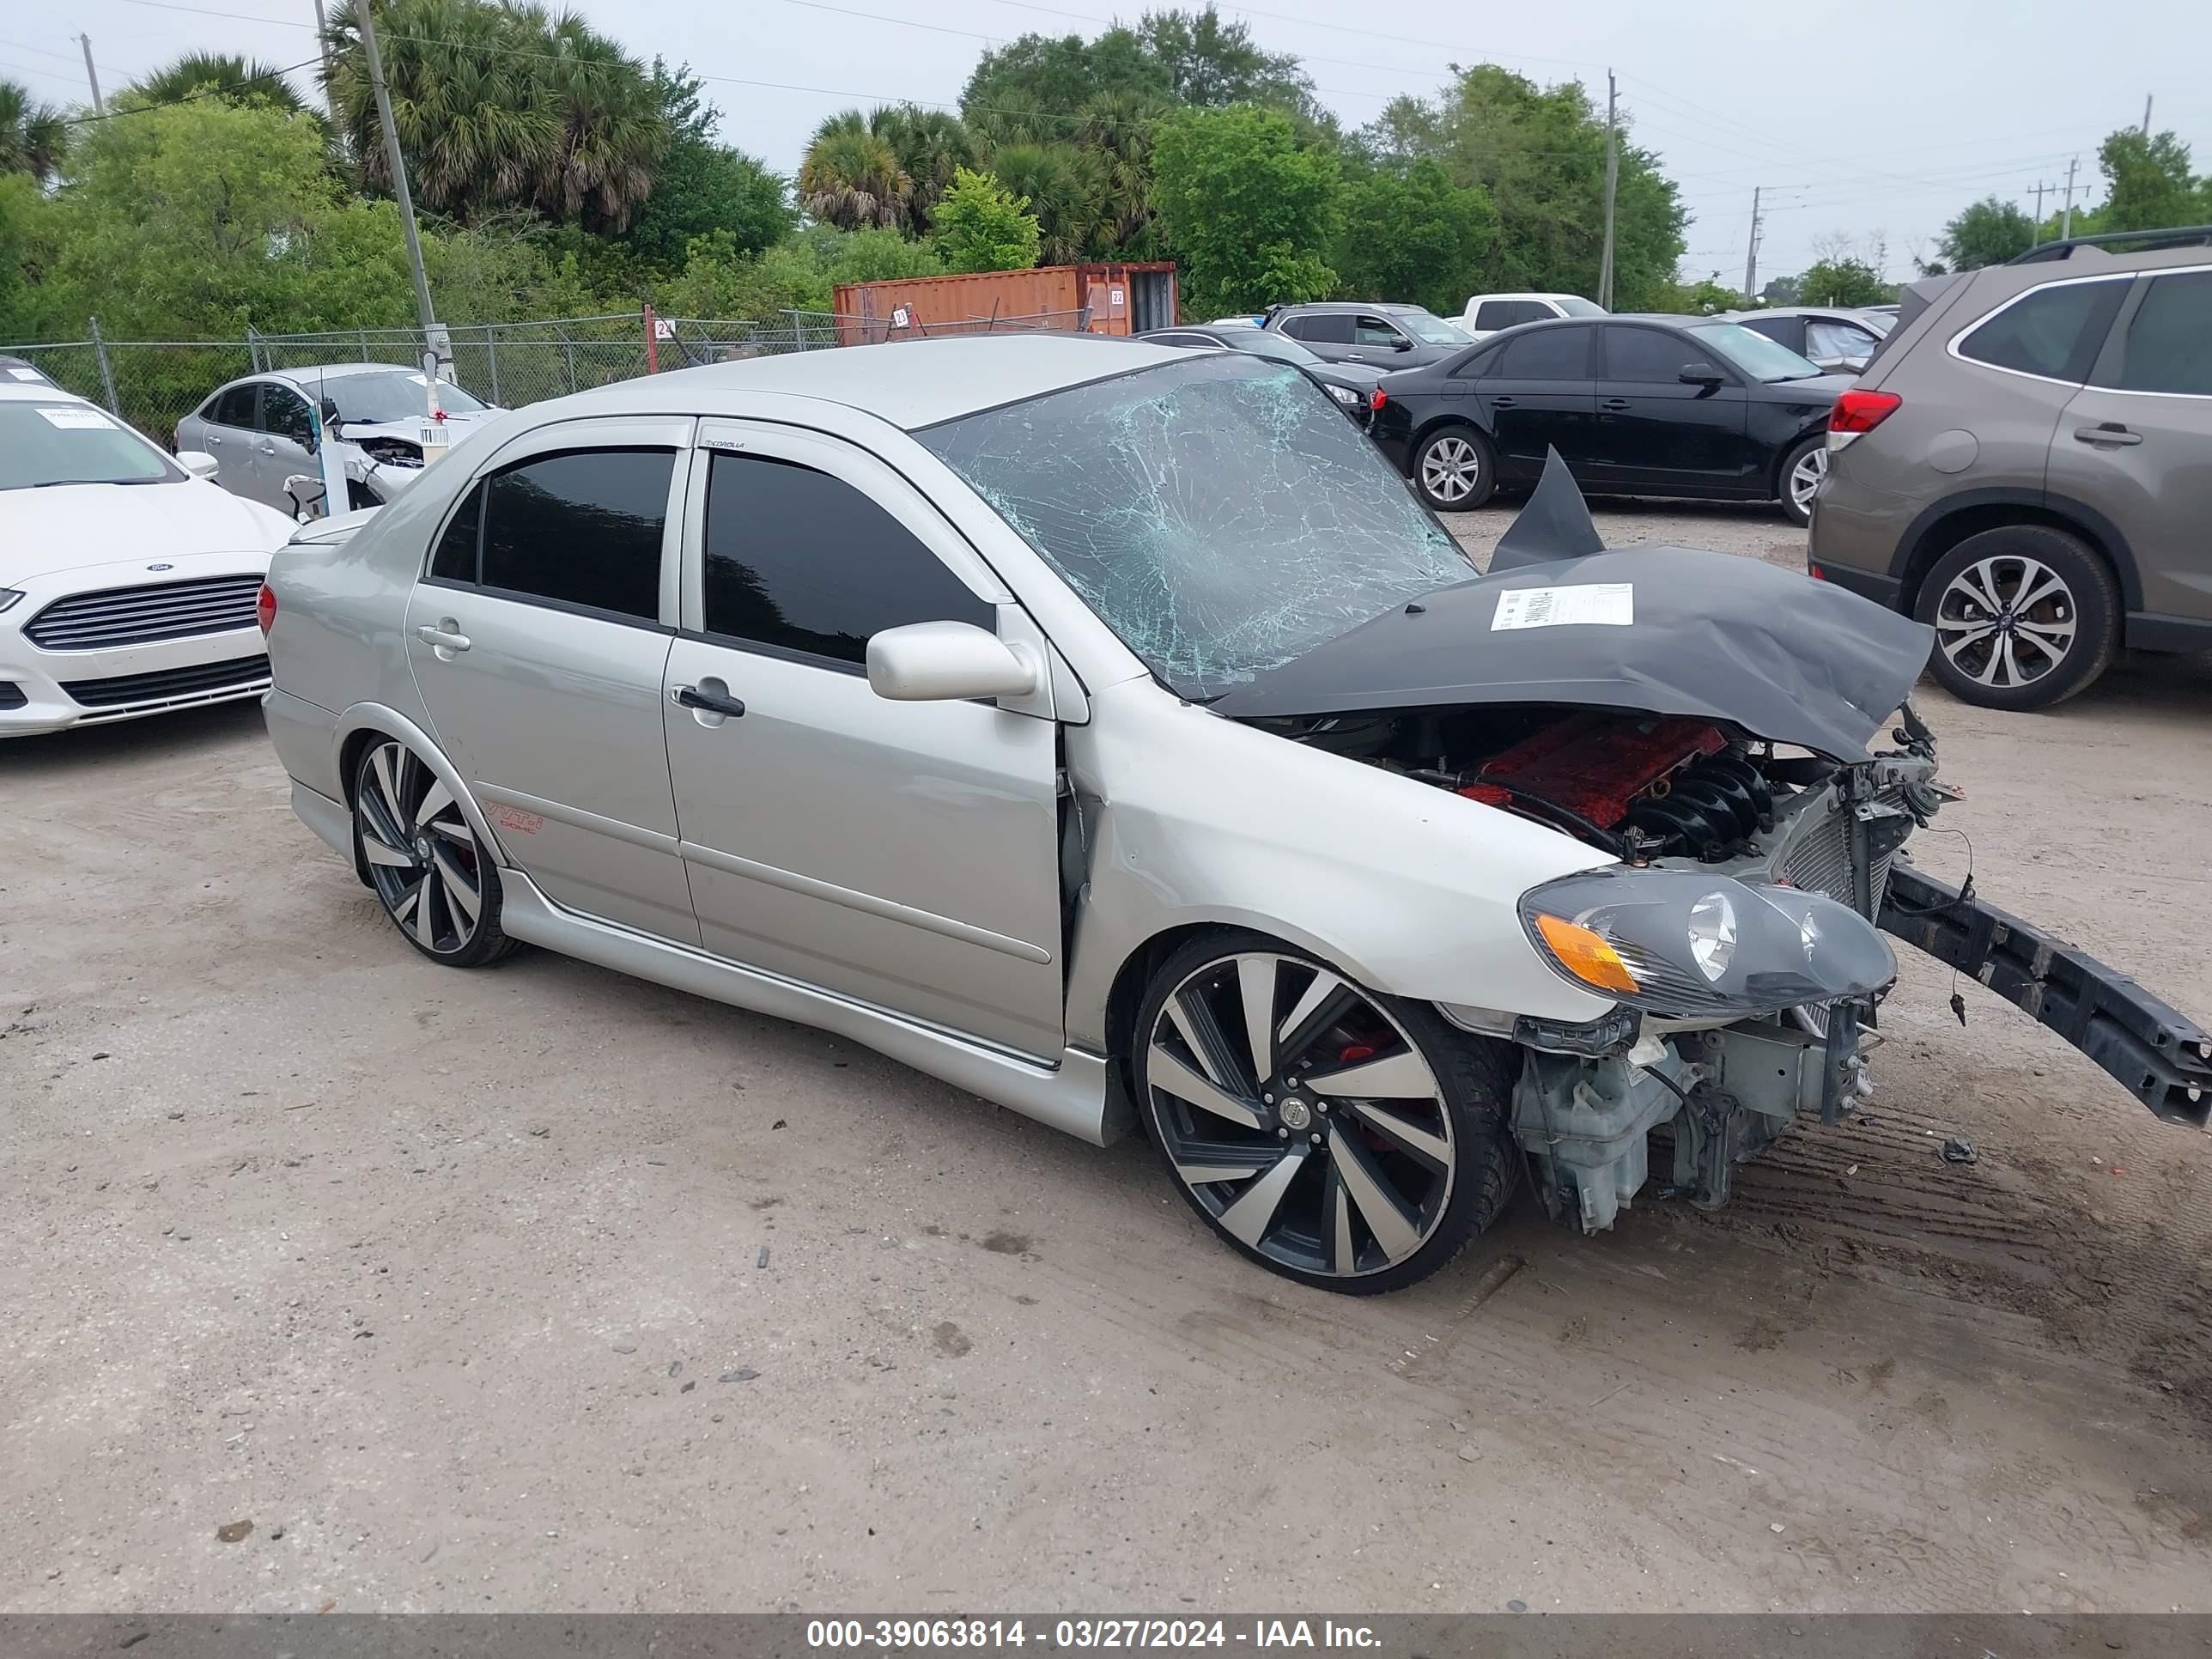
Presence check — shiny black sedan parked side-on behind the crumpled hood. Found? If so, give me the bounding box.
[1371,316,1851,525]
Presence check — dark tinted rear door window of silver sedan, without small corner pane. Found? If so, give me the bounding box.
[483,449,675,622]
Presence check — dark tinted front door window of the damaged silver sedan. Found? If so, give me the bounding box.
[702,453,998,664]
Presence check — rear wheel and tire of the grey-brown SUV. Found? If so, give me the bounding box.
[1913,525,2121,710]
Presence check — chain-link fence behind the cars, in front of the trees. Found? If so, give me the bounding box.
[0,310,1091,445]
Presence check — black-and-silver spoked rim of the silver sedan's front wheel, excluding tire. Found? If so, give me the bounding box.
[1144,951,1455,1279]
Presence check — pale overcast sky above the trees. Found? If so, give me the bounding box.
[0,0,2212,281]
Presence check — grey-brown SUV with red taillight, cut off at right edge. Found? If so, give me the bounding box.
[1812,228,2212,708]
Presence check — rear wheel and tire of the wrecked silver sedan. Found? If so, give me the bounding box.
[354,738,515,967]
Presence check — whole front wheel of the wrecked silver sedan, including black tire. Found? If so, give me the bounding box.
[1128,933,1517,1297]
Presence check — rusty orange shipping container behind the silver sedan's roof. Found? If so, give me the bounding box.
[836,261,1176,345]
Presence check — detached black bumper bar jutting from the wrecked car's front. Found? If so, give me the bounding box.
[1882,860,2212,1128]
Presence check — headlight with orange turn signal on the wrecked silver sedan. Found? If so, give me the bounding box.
[1520,869,1898,1018]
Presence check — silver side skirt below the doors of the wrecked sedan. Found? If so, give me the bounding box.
[500,865,1113,1146]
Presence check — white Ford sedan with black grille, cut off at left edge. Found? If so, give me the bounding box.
[0,385,296,737]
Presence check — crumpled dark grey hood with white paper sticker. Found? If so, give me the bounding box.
[1210,451,1936,761]
